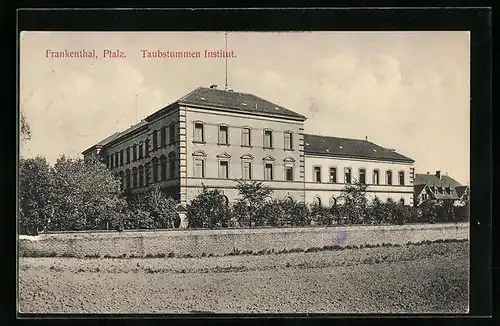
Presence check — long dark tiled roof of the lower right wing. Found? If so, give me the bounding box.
[304,134,414,162]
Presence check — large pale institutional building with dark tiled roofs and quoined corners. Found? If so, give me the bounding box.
[83,85,414,206]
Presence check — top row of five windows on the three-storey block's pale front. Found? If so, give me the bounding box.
[193,122,293,150]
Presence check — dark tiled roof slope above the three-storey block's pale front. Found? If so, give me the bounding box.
[178,87,306,120]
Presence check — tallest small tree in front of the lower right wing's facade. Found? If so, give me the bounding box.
[340,181,368,224]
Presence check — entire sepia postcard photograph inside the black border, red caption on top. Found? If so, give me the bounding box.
[17,31,471,315]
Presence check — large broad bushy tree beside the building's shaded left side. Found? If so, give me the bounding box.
[49,156,126,230]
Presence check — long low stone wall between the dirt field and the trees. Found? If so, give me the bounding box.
[19,223,469,257]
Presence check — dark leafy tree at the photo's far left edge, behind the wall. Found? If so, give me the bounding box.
[19,156,53,235]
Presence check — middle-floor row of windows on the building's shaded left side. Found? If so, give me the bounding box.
[116,155,177,189]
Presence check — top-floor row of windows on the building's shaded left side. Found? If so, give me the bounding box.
[106,123,176,169]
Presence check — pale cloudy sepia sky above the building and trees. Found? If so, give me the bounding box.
[19,31,470,184]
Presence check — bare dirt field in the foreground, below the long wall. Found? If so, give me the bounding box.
[19,242,469,313]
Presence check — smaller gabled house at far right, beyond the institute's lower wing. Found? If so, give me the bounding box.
[413,171,469,206]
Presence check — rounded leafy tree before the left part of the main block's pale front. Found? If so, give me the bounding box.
[186,185,231,228]
